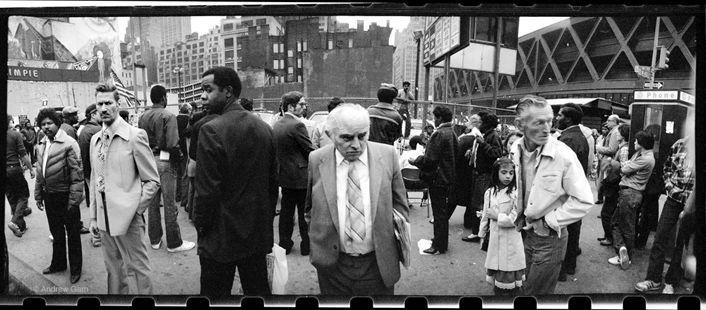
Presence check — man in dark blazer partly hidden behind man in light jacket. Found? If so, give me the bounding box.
[556,103,589,282]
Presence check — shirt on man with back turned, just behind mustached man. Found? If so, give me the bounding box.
[137,105,179,156]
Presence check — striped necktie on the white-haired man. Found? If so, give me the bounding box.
[345,161,365,242]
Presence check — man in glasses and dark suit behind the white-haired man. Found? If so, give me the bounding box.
[272,91,314,255]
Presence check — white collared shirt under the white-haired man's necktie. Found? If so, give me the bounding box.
[335,148,375,254]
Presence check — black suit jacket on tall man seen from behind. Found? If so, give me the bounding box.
[193,103,279,263]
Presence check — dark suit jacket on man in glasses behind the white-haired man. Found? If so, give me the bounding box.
[272,114,314,189]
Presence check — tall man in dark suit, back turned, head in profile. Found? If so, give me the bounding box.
[193,67,278,297]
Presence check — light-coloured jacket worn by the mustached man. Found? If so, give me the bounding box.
[89,117,159,236]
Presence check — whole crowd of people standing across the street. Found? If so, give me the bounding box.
[6,67,694,297]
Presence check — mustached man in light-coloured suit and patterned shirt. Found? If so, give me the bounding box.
[88,84,159,294]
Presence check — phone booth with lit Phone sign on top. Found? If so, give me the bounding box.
[630,90,695,177]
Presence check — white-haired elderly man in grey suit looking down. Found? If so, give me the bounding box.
[306,104,409,295]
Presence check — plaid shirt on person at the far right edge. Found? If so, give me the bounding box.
[663,137,695,203]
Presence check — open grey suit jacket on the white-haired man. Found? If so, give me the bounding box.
[305,142,409,287]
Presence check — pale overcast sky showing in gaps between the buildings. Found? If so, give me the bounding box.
[118,16,567,45]
